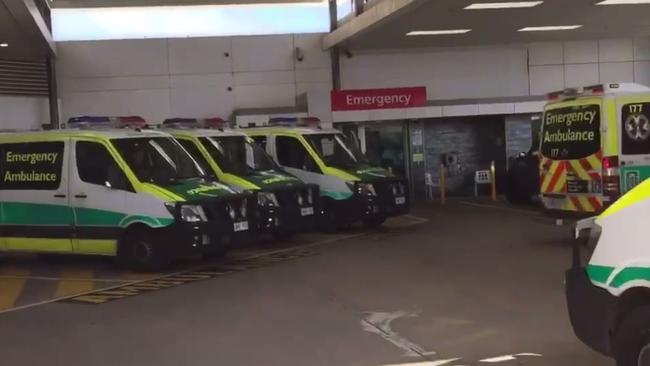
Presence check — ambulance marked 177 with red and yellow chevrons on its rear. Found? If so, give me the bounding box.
[540,83,650,214]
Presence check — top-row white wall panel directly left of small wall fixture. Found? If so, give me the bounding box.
[232,35,294,72]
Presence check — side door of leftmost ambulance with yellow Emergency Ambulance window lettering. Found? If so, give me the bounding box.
[0,139,73,252]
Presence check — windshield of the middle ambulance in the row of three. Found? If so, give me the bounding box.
[199,136,277,175]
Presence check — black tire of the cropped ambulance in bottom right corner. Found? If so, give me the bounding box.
[612,306,650,366]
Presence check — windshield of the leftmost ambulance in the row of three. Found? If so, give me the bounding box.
[112,137,205,186]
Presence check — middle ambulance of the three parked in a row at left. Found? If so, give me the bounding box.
[162,118,319,238]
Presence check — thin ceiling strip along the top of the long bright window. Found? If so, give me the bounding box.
[52,0,320,8]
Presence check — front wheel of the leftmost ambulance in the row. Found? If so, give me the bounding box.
[117,227,170,272]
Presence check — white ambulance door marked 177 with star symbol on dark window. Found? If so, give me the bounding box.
[616,95,650,193]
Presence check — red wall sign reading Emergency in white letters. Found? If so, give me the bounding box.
[332,86,427,111]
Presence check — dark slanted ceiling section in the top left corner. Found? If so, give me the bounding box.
[0,0,54,58]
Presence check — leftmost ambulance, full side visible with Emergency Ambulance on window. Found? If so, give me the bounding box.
[0,116,254,270]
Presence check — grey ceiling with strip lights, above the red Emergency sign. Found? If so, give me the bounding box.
[324,0,650,49]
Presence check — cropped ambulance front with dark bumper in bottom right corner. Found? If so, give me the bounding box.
[566,180,650,366]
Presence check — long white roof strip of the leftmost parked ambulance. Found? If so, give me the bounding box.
[0,128,170,142]
